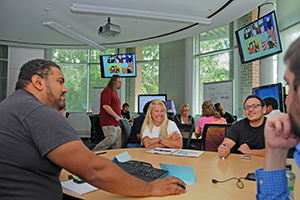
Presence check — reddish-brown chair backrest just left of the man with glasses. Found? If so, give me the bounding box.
[200,123,232,151]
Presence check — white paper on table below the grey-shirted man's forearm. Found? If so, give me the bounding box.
[61,180,98,195]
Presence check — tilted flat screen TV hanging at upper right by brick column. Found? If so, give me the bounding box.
[235,11,282,63]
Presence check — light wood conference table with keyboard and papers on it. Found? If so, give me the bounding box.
[60,148,300,200]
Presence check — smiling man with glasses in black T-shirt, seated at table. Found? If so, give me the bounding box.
[218,95,266,157]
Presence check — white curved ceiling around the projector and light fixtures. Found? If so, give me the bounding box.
[0,0,265,48]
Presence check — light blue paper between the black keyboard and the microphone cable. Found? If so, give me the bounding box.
[159,163,197,185]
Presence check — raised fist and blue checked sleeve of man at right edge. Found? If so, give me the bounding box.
[255,113,300,200]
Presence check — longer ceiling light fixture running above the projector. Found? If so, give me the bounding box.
[71,3,211,25]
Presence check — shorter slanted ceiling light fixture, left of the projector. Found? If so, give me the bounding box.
[43,21,106,51]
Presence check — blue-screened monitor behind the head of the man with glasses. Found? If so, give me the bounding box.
[252,83,284,112]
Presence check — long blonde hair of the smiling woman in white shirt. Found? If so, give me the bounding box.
[141,99,169,139]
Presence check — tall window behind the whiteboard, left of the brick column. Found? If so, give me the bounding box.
[194,24,231,114]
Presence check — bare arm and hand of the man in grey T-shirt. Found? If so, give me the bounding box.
[47,140,185,197]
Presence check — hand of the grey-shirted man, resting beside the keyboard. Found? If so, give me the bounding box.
[150,177,186,197]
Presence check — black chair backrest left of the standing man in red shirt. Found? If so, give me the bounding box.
[89,114,105,144]
